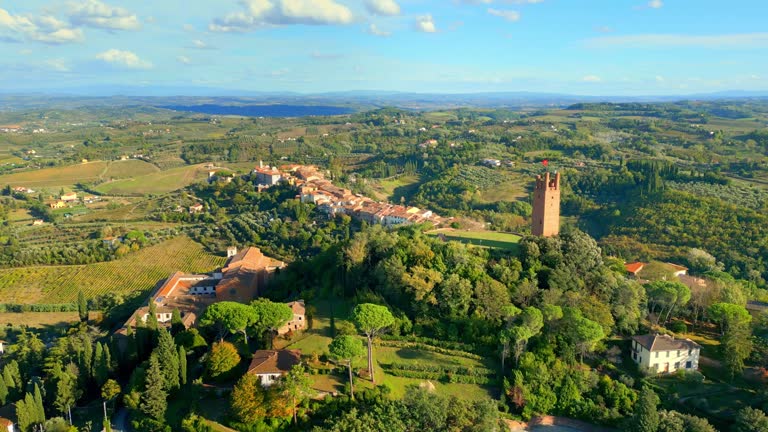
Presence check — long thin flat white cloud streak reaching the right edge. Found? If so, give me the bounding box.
[585,33,768,49]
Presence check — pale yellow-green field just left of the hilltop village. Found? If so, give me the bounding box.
[96,165,212,195]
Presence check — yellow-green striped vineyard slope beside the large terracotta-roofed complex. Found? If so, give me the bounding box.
[0,237,224,304]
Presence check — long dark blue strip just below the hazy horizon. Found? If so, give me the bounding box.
[164,104,355,117]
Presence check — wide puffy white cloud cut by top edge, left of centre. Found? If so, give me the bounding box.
[208,0,354,32]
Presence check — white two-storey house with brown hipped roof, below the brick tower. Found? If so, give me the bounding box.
[632,334,701,373]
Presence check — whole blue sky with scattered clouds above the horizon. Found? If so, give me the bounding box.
[0,0,768,95]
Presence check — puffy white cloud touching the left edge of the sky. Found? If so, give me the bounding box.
[0,9,83,44]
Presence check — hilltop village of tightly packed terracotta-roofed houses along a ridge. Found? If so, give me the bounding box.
[251,162,448,226]
